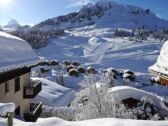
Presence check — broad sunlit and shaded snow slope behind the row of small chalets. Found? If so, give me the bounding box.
[38,26,162,73]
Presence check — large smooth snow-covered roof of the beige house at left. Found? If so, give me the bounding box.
[0,31,40,72]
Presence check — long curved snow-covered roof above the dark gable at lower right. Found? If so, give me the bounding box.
[109,86,168,110]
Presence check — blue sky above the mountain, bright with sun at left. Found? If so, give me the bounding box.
[0,0,168,25]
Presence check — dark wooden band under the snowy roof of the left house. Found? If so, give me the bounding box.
[0,67,31,84]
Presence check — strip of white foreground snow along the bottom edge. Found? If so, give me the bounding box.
[0,117,168,126]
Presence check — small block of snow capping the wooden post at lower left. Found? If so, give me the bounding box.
[0,103,15,116]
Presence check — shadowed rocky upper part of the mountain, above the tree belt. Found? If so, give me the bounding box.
[34,0,168,30]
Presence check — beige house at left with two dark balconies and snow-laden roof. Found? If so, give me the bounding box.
[0,32,42,121]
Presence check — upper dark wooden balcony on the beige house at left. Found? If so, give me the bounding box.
[23,81,42,99]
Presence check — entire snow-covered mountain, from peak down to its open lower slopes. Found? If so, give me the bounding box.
[6,0,168,72]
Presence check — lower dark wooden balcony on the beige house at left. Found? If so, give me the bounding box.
[23,102,42,122]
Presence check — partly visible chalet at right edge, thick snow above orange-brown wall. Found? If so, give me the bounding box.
[149,41,168,86]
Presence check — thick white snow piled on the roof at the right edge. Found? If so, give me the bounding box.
[149,41,168,75]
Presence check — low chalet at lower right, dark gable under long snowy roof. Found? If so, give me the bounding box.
[109,86,168,115]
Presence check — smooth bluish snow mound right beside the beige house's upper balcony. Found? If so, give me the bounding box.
[32,77,75,107]
